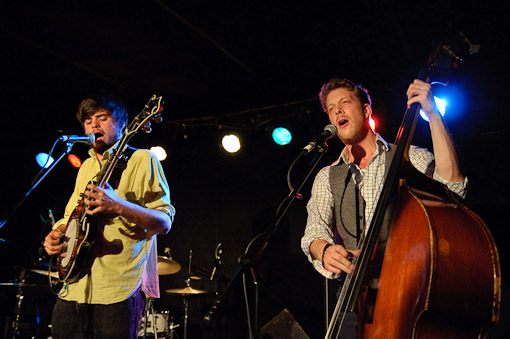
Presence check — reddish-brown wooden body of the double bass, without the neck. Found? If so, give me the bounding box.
[358,171,501,339]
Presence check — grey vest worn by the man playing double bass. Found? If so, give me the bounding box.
[329,144,396,250]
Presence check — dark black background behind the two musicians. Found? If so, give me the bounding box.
[0,0,510,338]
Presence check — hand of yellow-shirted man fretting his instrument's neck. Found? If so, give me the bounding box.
[84,183,123,215]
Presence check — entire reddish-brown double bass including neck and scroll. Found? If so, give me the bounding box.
[325,35,501,339]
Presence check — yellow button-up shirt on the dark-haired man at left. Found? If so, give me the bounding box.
[55,146,175,305]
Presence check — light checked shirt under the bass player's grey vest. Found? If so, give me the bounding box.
[301,134,467,278]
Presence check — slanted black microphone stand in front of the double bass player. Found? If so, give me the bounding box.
[203,142,327,338]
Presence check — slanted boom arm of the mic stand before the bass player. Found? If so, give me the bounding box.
[204,145,327,324]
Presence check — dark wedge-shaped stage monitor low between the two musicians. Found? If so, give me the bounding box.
[259,308,310,339]
